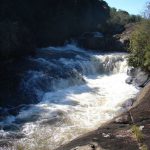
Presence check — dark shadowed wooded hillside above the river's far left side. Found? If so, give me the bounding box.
[0,0,109,59]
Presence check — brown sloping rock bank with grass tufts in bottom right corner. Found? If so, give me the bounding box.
[57,83,150,150]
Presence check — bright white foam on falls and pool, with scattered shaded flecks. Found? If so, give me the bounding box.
[0,44,138,150]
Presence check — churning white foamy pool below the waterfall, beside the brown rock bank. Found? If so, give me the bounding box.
[10,73,137,149]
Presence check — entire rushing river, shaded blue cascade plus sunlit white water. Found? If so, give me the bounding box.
[0,44,138,150]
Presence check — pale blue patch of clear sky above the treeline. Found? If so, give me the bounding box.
[105,0,149,15]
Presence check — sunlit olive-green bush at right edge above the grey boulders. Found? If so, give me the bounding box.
[128,20,150,71]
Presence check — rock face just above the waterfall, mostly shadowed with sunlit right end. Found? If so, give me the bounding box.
[78,24,135,51]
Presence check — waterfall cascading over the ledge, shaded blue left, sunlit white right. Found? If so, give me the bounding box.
[20,45,127,101]
